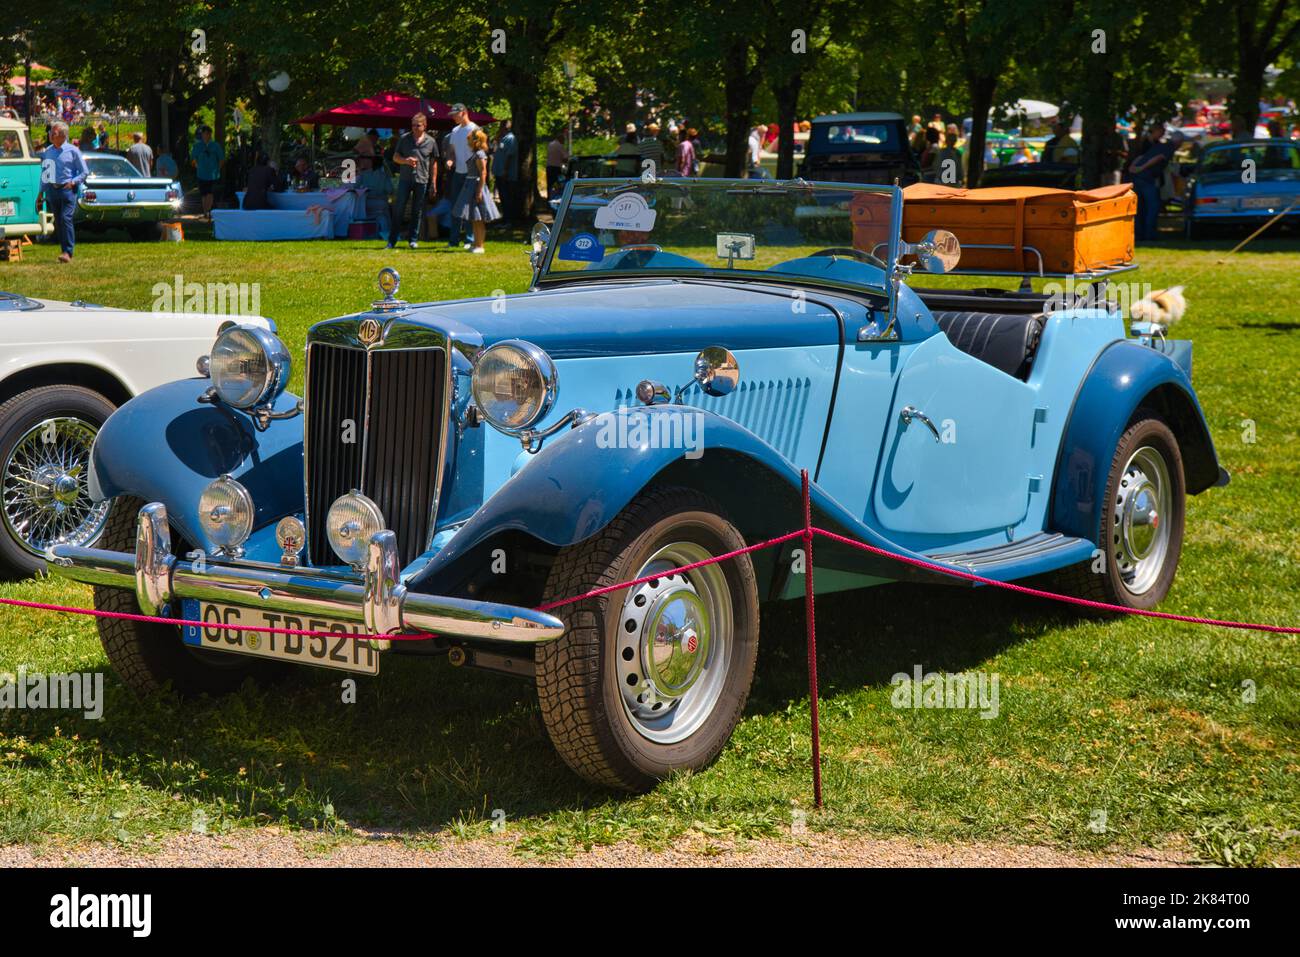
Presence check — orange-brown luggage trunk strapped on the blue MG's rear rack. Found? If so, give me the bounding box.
[902,183,1138,274]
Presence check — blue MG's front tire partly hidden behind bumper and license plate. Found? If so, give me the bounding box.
[95,497,287,697]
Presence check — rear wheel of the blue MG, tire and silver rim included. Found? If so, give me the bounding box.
[1062,410,1186,609]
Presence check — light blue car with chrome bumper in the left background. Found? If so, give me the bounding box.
[74,153,185,239]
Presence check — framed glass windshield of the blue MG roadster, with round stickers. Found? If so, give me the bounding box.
[541,178,901,289]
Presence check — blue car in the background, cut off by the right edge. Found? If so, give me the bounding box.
[1183,139,1300,239]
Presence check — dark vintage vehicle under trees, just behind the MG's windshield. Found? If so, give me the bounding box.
[800,113,920,186]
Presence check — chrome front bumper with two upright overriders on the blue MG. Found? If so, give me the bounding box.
[49,502,564,644]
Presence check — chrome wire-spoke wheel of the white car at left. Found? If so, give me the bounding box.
[0,416,111,555]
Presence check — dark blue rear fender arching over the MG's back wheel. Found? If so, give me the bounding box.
[1050,339,1227,542]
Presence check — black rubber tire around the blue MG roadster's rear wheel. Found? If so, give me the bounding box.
[1052,408,1187,609]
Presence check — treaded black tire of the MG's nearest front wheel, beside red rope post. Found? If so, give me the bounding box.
[536,488,759,792]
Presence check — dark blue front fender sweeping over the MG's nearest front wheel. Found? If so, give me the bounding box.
[408,406,952,590]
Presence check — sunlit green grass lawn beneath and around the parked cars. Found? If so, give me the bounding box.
[0,226,1300,863]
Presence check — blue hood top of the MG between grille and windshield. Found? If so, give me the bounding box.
[403,280,842,359]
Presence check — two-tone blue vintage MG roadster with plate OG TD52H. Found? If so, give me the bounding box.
[51,179,1226,789]
